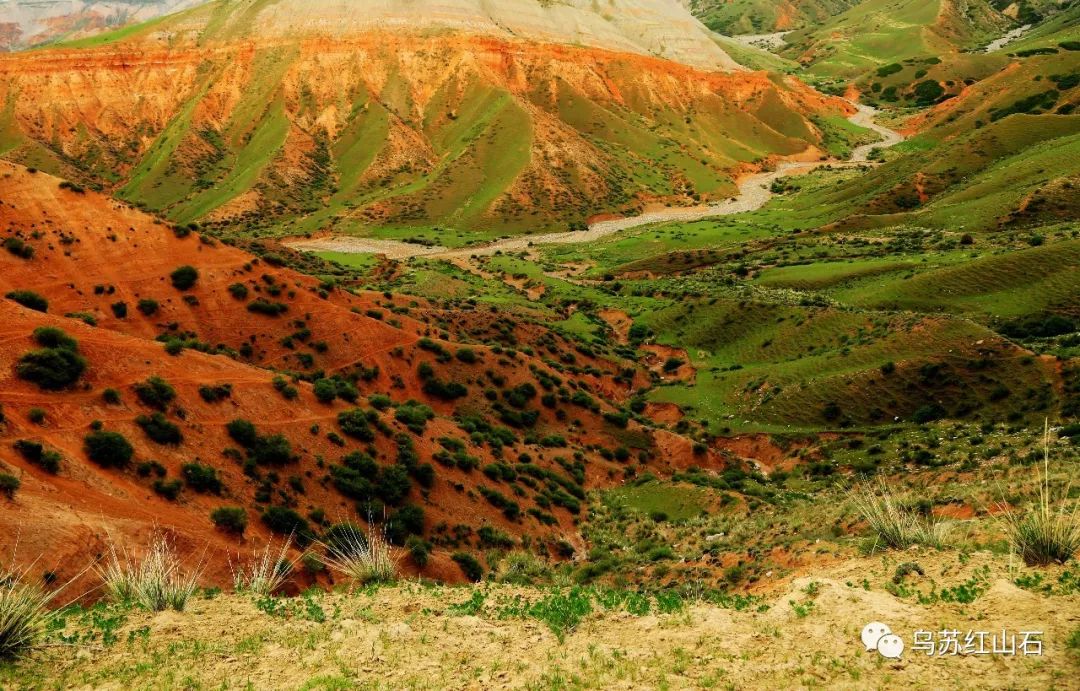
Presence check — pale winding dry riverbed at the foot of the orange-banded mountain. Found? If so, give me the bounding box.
[284,104,904,260]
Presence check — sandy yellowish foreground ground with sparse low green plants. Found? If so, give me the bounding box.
[0,553,1080,689]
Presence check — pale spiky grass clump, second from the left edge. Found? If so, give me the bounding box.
[96,534,202,612]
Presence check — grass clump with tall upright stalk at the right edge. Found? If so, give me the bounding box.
[1004,422,1080,566]
